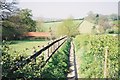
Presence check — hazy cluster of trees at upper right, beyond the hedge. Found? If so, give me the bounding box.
[85,11,119,34]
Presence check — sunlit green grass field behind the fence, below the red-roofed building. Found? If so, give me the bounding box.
[9,41,48,55]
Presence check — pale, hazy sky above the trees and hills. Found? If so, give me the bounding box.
[19,0,118,19]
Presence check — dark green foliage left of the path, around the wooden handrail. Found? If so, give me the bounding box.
[1,41,70,80]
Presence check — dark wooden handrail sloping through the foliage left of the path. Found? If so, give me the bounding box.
[10,36,67,74]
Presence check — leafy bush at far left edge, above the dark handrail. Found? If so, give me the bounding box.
[1,41,26,77]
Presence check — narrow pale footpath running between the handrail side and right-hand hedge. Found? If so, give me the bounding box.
[67,42,78,80]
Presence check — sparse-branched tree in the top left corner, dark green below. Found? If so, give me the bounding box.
[0,0,22,39]
